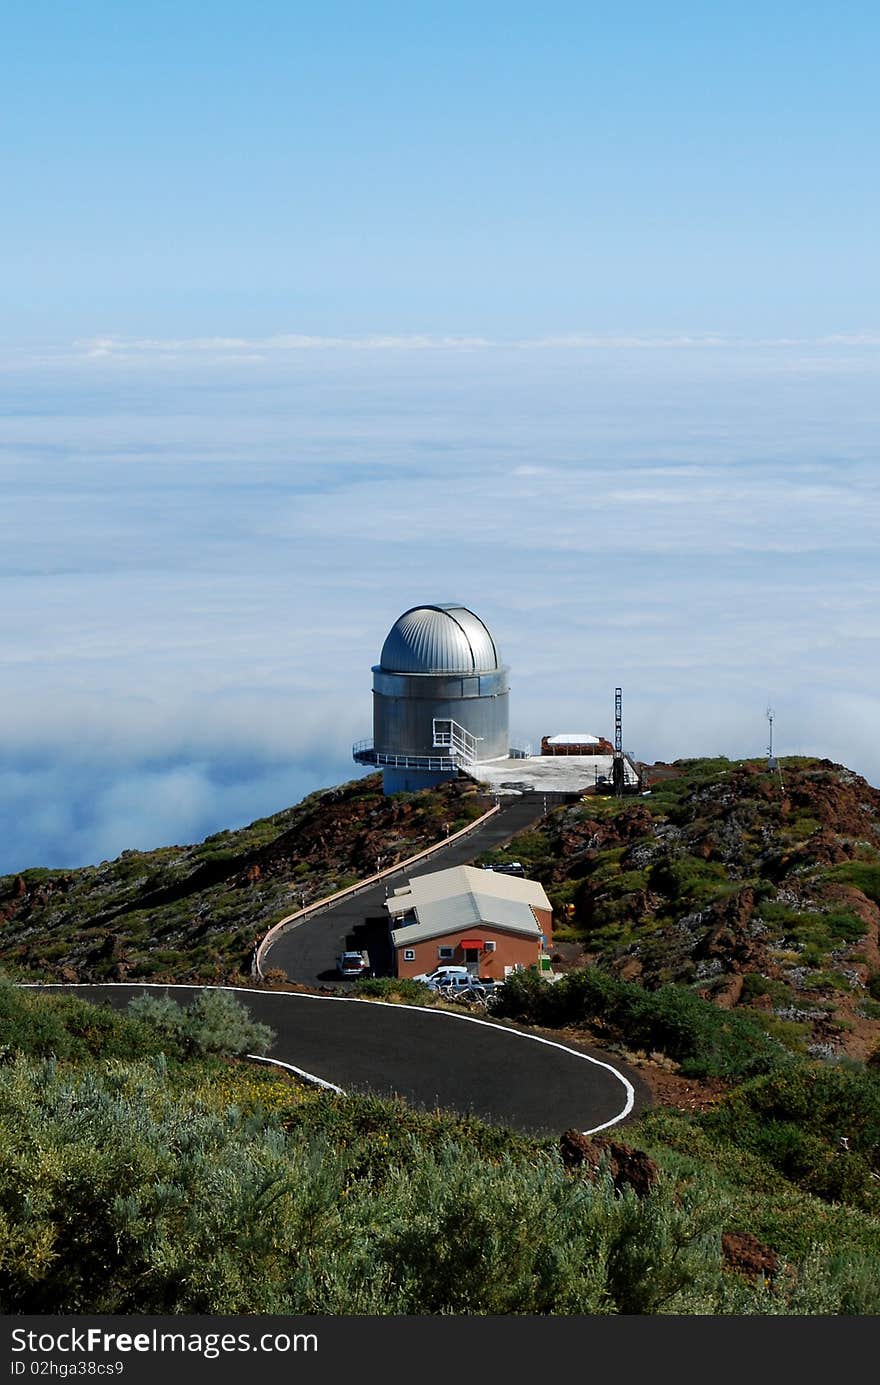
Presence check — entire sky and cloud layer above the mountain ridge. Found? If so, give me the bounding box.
[0,0,880,870]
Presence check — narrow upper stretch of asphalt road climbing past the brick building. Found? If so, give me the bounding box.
[263,794,556,986]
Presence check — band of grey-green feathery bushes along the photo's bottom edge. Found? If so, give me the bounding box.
[0,1058,877,1316]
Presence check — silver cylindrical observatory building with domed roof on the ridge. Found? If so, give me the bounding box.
[353,601,510,794]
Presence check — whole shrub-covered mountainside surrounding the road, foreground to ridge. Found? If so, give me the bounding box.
[0,759,880,1316]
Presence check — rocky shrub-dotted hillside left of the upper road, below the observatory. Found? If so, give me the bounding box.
[0,774,491,982]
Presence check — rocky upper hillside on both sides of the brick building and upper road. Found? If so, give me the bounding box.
[0,759,880,1058]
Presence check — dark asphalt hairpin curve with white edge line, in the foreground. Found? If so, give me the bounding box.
[40,985,644,1134]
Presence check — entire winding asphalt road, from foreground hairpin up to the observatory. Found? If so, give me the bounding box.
[24,795,647,1136]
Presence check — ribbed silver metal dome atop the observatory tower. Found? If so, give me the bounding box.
[378,601,502,673]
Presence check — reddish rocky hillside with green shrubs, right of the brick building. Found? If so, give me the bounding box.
[481,759,880,1058]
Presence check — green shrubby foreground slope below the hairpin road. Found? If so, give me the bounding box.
[0,988,880,1314]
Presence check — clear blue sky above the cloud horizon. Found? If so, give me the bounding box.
[6,0,880,341]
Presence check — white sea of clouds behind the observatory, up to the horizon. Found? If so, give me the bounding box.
[0,334,880,873]
